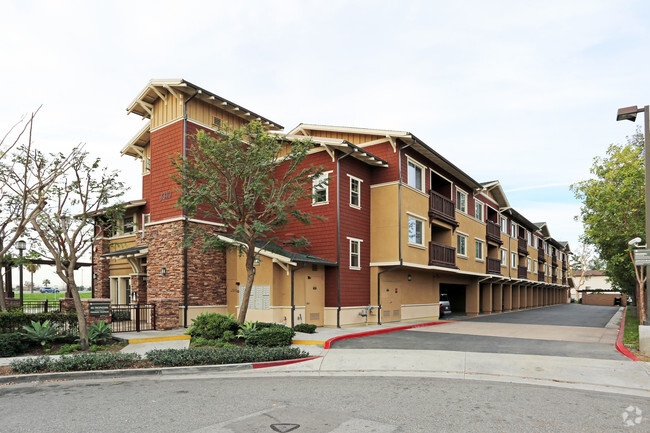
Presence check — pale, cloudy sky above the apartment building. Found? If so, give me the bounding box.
[0,0,650,285]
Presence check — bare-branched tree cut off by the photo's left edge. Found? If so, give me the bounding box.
[0,107,79,311]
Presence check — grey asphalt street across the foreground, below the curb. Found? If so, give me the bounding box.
[0,376,650,433]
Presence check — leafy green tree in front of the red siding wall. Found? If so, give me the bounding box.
[174,121,322,323]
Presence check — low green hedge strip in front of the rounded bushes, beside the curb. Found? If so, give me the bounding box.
[146,347,309,367]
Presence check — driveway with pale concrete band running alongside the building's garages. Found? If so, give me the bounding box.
[332,304,627,360]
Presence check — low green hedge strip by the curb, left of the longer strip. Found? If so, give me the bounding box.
[11,352,142,373]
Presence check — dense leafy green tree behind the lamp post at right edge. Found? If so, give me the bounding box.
[571,132,646,304]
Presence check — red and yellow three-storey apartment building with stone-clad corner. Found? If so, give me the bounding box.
[93,80,569,329]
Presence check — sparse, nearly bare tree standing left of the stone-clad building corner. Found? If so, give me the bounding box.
[31,152,126,350]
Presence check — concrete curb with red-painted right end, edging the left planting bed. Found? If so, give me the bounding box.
[0,356,321,385]
